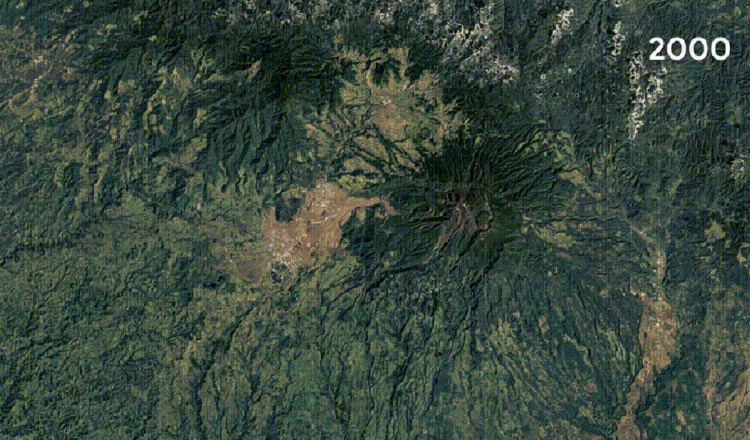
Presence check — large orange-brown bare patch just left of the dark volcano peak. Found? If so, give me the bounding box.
[263,183,392,271]
